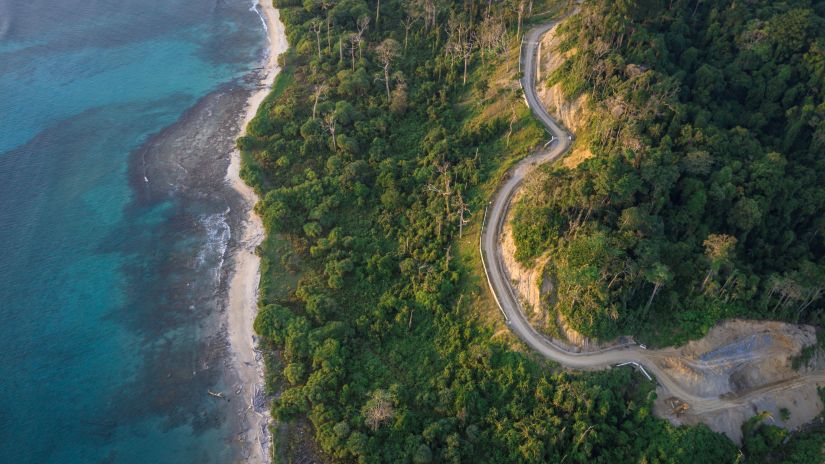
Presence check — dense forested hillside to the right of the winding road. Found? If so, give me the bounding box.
[514,0,825,344]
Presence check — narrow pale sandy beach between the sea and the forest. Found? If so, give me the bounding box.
[226,0,287,463]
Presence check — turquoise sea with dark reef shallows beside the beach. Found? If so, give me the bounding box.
[0,0,265,463]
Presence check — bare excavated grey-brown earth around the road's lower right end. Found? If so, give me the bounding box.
[654,320,823,443]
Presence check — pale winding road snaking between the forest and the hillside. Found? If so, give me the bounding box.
[481,23,825,412]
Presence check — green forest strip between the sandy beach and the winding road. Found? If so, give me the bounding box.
[239,0,822,464]
